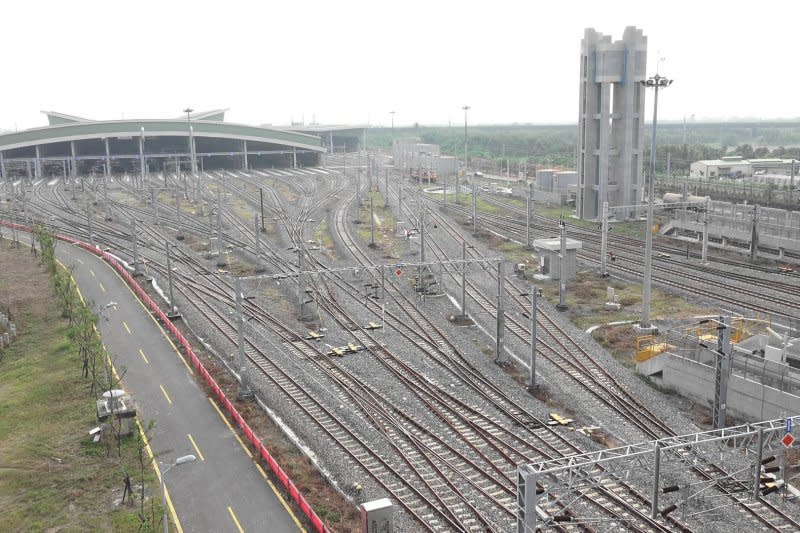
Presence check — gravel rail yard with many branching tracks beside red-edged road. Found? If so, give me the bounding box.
[0,153,800,532]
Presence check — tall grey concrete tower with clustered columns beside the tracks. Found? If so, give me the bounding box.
[577,26,647,219]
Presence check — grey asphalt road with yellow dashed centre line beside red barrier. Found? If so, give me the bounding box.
[56,242,304,533]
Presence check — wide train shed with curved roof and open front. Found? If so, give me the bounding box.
[0,109,326,179]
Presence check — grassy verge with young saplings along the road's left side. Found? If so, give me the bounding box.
[0,228,162,532]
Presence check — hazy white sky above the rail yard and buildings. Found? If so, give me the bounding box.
[0,0,800,129]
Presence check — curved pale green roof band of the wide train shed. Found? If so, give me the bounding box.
[0,119,325,152]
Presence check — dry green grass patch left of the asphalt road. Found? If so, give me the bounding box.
[0,246,160,531]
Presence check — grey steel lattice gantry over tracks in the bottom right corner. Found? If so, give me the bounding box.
[517,415,800,533]
